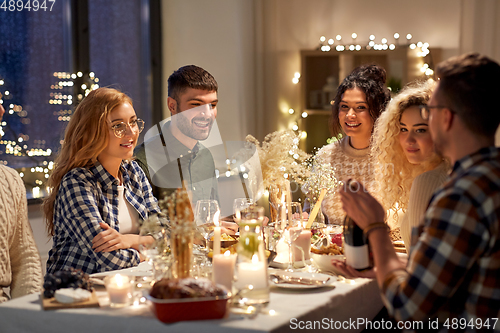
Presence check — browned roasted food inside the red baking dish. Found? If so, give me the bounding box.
[150,278,227,299]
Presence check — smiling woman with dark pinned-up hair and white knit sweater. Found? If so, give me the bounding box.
[302,65,391,224]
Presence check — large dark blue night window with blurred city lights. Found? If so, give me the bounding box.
[0,0,161,199]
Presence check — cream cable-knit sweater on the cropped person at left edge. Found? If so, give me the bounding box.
[0,165,43,303]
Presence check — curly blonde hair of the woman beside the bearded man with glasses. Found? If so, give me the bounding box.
[371,81,443,211]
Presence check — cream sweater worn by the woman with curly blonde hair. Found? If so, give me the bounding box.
[400,164,448,253]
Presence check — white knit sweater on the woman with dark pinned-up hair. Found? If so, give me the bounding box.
[310,137,375,224]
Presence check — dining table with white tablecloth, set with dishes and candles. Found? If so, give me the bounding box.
[0,264,383,333]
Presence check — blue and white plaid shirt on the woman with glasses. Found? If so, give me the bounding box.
[47,161,160,274]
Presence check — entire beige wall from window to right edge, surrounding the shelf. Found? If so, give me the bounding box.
[162,0,500,140]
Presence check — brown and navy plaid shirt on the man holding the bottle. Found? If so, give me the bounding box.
[382,147,500,331]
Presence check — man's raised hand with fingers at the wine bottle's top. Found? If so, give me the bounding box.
[340,179,385,229]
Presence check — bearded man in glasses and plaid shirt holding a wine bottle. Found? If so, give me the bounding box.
[341,54,500,331]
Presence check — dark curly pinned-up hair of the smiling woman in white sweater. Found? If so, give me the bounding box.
[330,65,391,138]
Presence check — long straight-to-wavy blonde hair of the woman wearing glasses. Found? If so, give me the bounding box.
[42,88,132,236]
